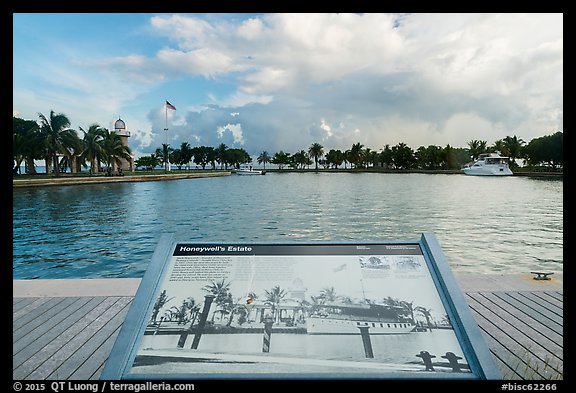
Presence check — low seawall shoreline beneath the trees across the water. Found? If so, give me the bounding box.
[12,168,564,187]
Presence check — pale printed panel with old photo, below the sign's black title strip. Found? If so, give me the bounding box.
[131,251,470,374]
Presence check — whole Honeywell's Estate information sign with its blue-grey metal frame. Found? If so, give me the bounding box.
[101,234,500,379]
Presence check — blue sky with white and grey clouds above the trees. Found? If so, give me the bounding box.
[13,13,564,157]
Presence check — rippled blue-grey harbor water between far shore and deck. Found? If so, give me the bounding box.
[12,171,563,279]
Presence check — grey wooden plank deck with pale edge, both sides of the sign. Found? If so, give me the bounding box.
[12,274,563,380]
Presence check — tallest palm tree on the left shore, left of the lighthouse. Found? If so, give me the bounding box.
[38,110,77,176]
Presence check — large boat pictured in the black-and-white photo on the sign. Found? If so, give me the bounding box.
[306,304,416,334]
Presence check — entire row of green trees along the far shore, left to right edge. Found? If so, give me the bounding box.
[12,111,564,176]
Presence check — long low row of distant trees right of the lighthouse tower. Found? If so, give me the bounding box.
[129,131,564,170]
